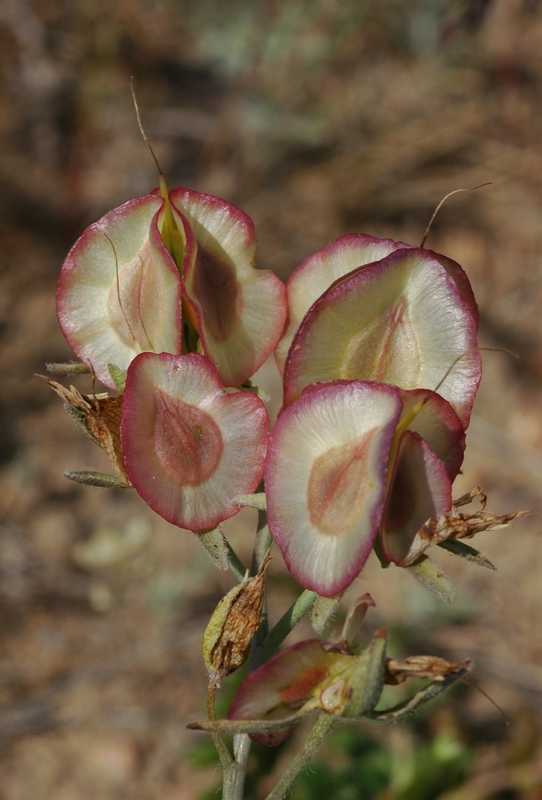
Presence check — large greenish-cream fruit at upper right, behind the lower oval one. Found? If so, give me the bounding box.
[284,248,481,428]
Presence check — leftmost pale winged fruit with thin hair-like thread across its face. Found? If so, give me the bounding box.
[57,195,182,389]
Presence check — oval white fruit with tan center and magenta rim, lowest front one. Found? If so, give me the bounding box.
[265,381,402,597]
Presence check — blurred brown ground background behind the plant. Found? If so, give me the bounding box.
[0,0,542,800]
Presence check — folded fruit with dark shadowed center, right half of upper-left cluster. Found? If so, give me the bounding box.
[169,189,287,386]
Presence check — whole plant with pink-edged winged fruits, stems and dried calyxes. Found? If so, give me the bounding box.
[44,166,528,800]
